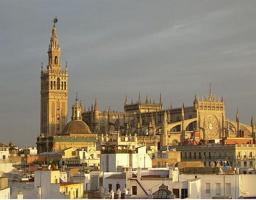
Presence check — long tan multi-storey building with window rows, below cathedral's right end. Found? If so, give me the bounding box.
[177,144,256,168]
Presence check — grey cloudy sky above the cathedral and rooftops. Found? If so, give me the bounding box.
[0,0,256,146]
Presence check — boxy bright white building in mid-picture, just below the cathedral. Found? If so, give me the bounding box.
[100,146,152,172]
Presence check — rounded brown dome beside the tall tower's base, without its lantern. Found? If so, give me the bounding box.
[63,120,91,135]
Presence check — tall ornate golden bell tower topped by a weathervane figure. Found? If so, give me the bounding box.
[40,18,68,136]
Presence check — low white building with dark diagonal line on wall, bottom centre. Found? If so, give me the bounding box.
[99,168,196,198]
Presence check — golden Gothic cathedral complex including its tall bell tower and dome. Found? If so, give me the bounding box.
[37,19,255,152]
